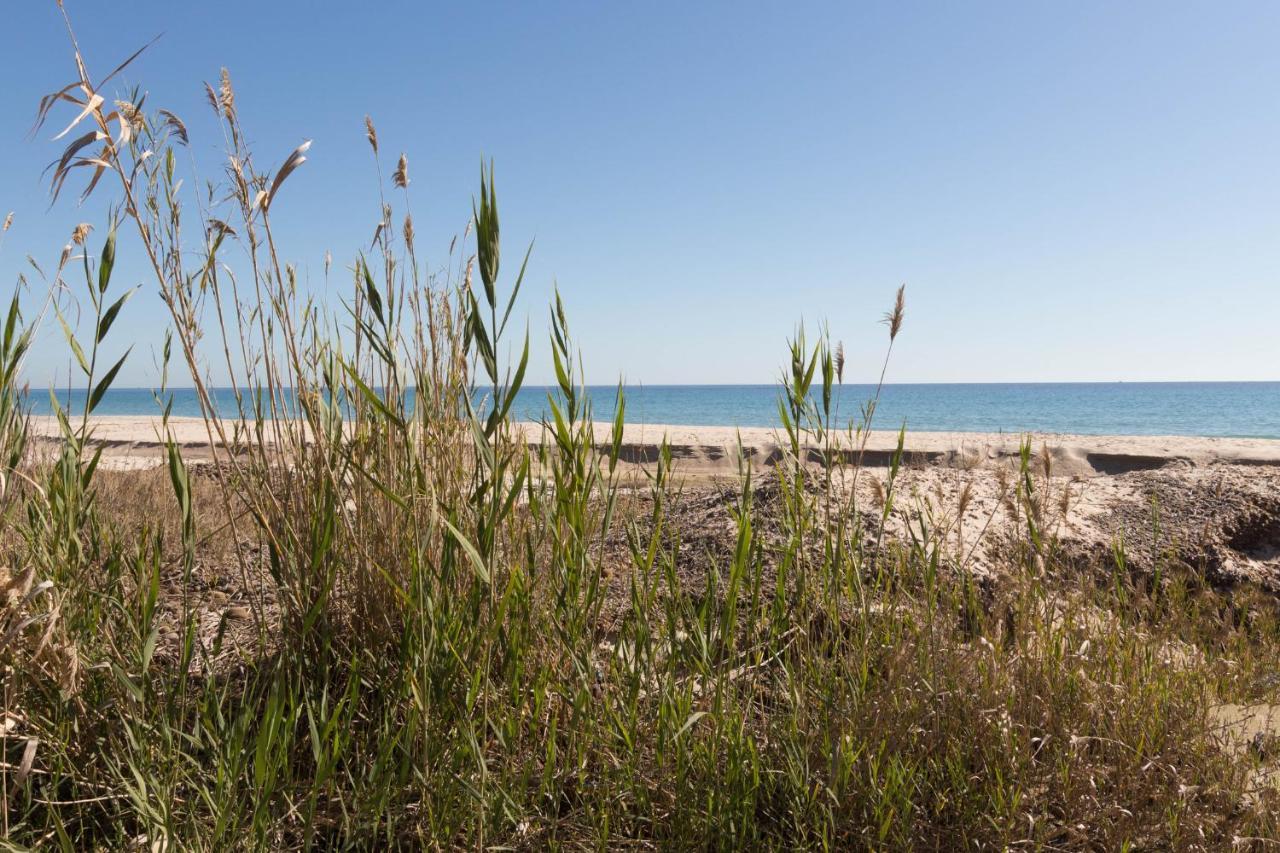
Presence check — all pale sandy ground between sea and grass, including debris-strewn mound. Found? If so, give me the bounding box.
[24,416,1280,592]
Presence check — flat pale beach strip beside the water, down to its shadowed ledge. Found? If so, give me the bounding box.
[31,415,1280,476]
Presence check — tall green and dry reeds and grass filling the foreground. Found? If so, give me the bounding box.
[0,9,1280,849]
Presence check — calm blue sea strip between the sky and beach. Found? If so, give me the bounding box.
[32,382,1280,438]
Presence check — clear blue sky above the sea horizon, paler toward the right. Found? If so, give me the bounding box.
[0,0,1280,386]
